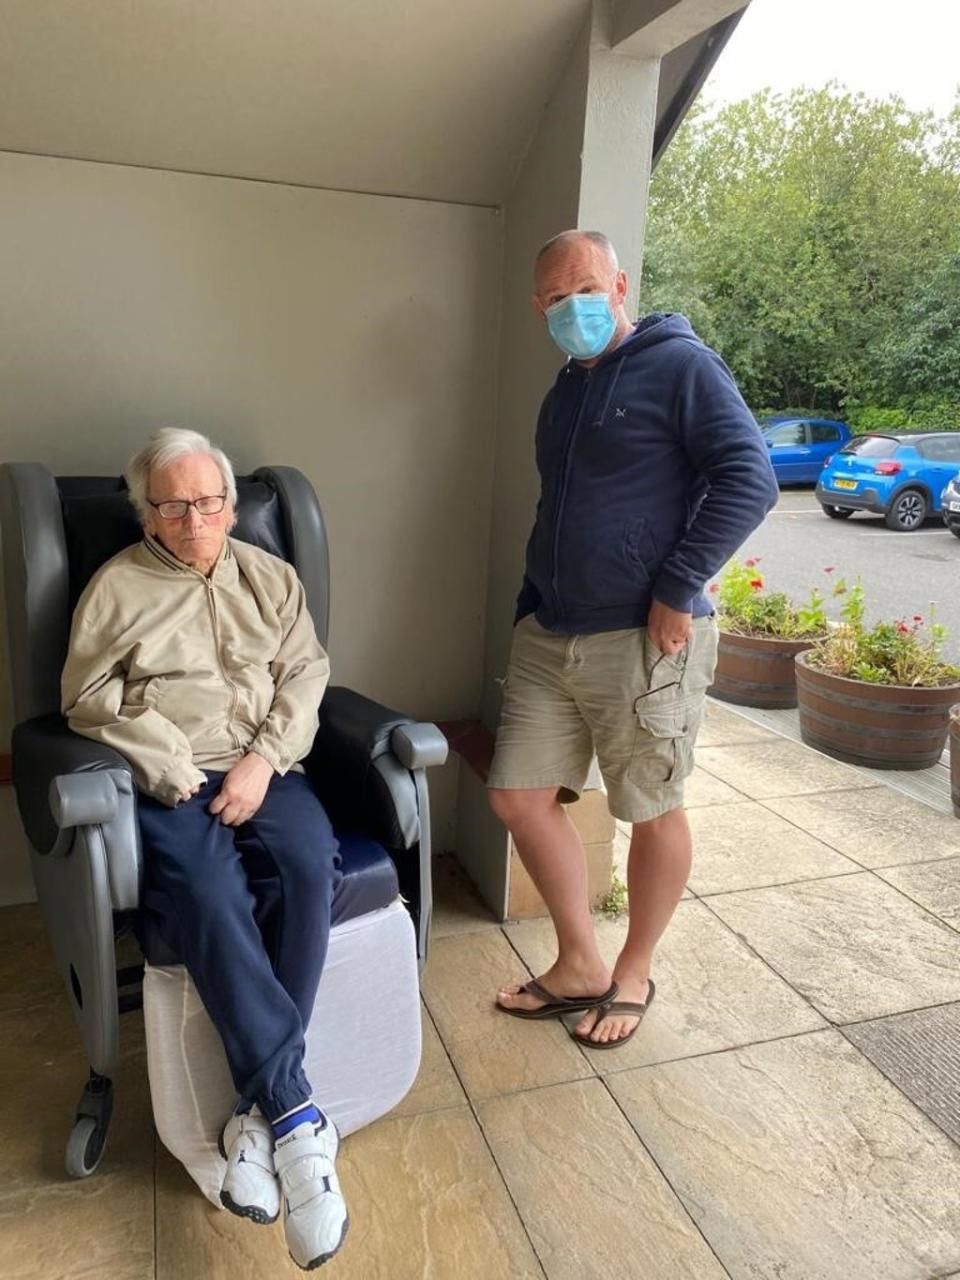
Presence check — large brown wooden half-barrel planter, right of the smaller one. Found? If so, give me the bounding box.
[796,654,960,769]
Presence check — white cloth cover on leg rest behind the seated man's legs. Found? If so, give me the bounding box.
[143,902,420,1208]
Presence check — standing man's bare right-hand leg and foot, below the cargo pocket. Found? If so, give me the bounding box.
[576,809,692,1042]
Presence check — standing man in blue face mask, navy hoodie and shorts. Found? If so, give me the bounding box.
[488,232,777,1048]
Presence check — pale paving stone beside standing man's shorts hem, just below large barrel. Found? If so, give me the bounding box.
[698,739,876,800]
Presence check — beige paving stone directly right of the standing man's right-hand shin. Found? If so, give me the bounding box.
[689,801,860,897]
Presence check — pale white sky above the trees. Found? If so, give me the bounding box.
[703,0,960,115]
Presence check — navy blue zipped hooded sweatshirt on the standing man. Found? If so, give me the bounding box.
[517,314,778,635]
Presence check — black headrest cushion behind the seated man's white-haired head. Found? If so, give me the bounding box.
[56,476,291,609]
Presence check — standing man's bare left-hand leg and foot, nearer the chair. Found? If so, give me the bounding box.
[489,787,611,1009]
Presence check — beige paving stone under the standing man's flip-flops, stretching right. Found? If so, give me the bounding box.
[507,901,826,1074]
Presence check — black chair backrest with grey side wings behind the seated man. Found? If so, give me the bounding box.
[0,462,330,723]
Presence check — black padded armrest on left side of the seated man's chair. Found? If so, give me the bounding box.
[13,716,133,854]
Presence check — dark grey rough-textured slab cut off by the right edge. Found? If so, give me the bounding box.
[844,1005,960,1143]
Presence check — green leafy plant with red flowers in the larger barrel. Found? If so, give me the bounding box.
[806,581,960,689]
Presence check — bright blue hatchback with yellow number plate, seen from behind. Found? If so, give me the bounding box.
[817,431,960,534]
